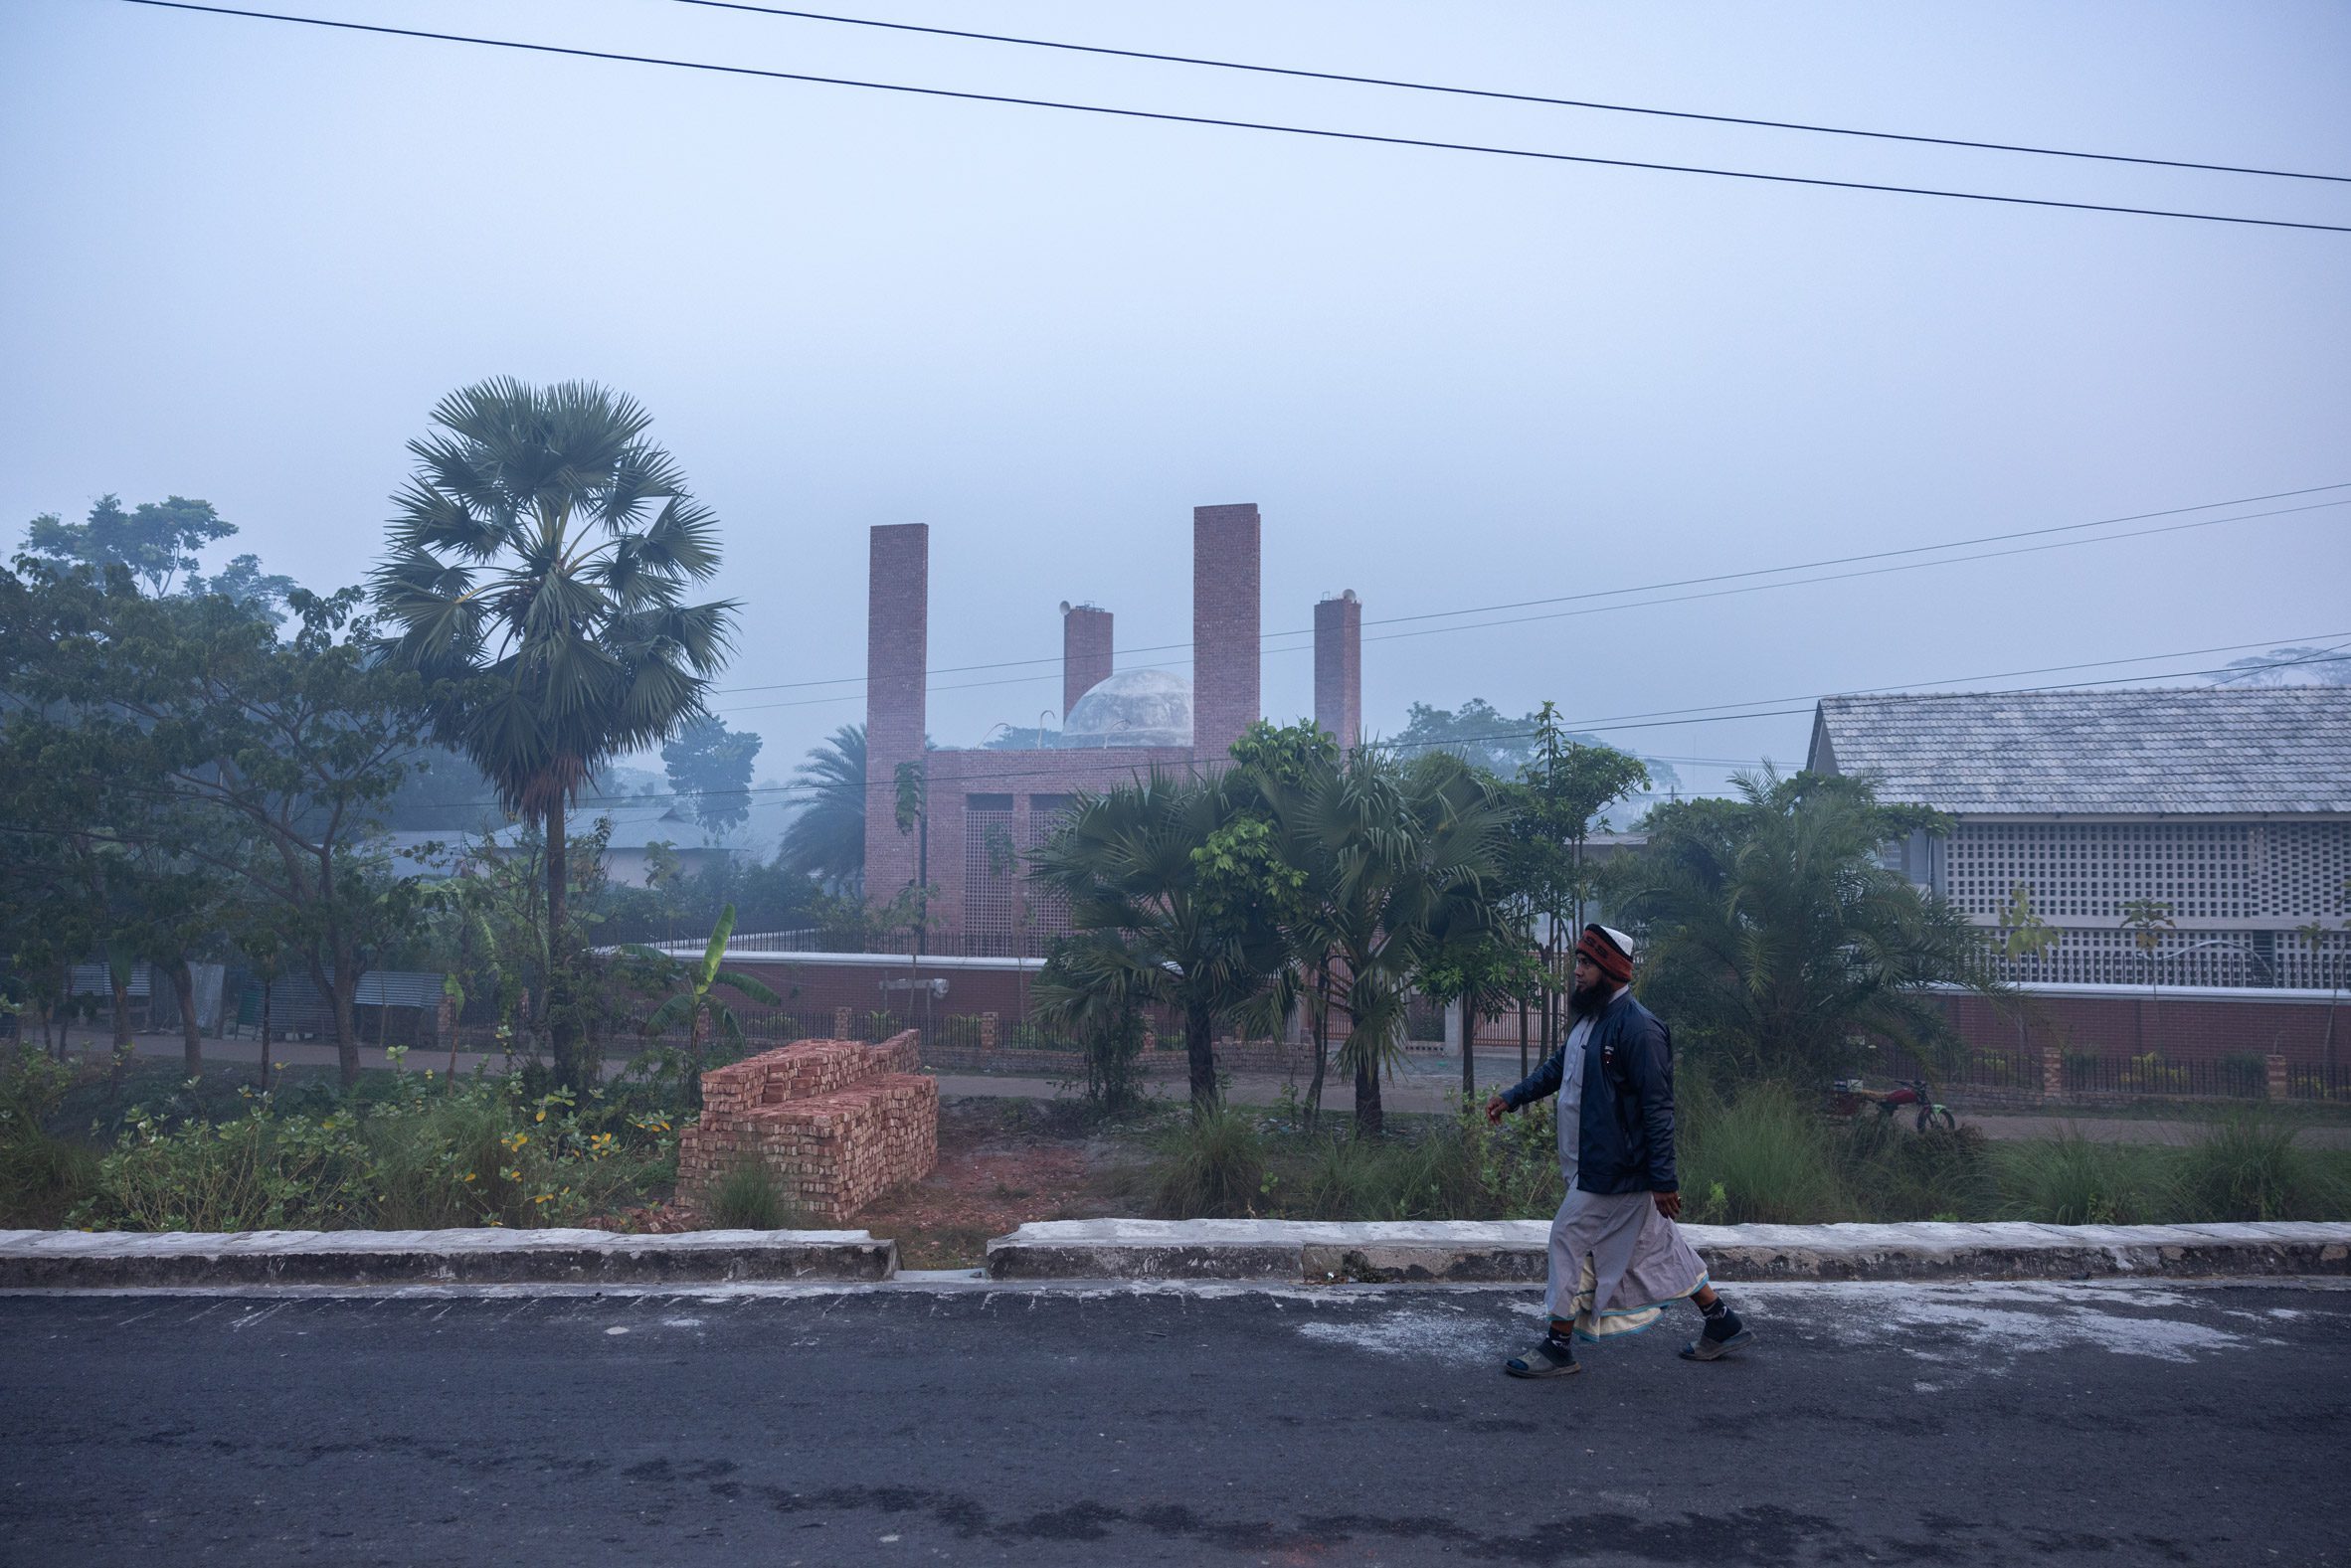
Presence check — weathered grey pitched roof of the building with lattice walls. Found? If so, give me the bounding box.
[1808,686,2351,815]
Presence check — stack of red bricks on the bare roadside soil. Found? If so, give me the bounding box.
[677,1030,938,1222]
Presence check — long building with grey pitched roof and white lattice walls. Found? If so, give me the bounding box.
[1808,686,2351,987]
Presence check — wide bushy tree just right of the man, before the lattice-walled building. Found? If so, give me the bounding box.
[1608,771,1998,1084]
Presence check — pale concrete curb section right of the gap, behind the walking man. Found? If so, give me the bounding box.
[988,1220,2351,1284]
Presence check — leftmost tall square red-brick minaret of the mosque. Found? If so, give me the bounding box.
[865,522,931,903]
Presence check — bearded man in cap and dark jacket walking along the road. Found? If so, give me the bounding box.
[1486,927,1756,1377]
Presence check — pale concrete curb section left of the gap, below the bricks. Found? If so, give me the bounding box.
[0,1230,898,1291]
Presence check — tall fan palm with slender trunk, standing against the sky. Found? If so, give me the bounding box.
[374,379,736,1086]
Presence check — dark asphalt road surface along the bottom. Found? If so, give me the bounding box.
[0,1282,2351,1568]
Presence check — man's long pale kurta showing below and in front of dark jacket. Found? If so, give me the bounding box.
[1542,991,1707,1340]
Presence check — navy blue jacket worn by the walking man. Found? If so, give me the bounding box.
[1503,992,1679,1194]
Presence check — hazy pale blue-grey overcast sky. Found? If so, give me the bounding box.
[0,0,2351,787]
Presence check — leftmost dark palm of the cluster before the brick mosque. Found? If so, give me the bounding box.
[1029,769,1284,1115]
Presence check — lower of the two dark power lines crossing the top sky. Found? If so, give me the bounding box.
[122,0,2351,235]
